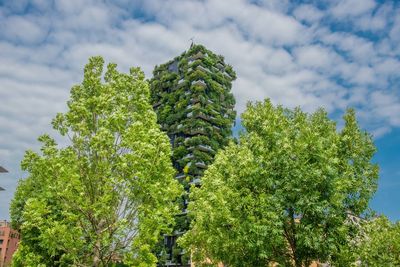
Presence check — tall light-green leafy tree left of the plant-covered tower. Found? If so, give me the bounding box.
[11,57,181,266]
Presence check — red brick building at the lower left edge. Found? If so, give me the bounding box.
[0,221,19,267]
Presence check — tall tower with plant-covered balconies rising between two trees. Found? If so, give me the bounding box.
[150,45,236,266]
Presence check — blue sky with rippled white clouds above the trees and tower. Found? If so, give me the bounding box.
[0,0,400,220]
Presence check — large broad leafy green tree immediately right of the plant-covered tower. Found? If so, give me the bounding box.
[180,100,378,266]
